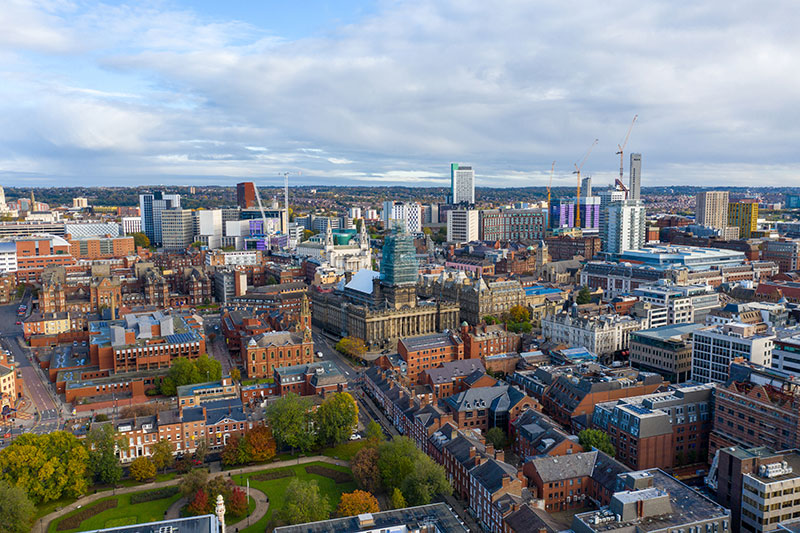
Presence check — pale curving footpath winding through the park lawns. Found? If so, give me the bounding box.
[36,455,348,533]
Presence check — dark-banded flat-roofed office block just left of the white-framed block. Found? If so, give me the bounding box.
[630,324,704,383]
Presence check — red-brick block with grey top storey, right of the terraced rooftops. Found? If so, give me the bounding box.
[591,384,714,471]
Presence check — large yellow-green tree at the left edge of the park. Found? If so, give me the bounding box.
[0,431,89,503]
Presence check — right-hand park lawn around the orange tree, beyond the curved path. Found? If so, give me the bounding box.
[233,462,357,533]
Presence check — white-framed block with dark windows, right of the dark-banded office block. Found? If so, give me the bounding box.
[692,322,775,383]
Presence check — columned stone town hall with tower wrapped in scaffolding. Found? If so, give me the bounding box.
[311,228,459,349]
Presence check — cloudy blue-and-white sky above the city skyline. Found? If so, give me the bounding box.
[0,0,800,187]
